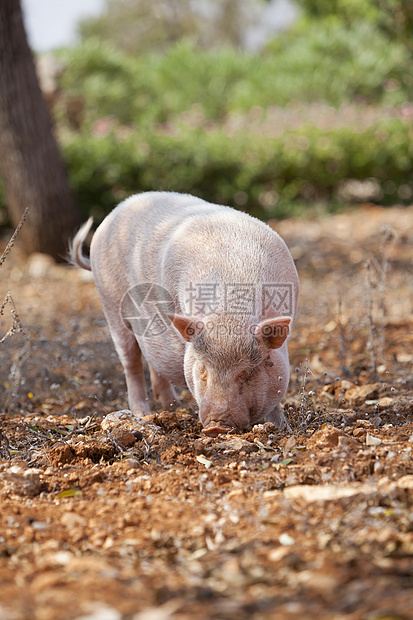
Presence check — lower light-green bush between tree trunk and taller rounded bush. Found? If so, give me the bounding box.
[58,39,251,124]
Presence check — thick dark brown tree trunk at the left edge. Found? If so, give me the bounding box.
[0,0,80,260]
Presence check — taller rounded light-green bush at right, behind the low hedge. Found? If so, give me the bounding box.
[249,19,412,106]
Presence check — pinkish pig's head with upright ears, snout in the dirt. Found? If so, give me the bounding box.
[171,315,291,436]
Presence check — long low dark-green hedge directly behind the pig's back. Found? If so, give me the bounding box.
[58,119,413,219]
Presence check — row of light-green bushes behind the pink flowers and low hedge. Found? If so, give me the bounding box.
[58,26,413,126]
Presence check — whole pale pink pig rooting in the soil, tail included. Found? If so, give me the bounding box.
[70,192,299,437]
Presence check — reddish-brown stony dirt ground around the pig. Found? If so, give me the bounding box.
[0,205,413,620]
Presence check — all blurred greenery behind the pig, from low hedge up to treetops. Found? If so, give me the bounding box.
[6,0,413,220]
